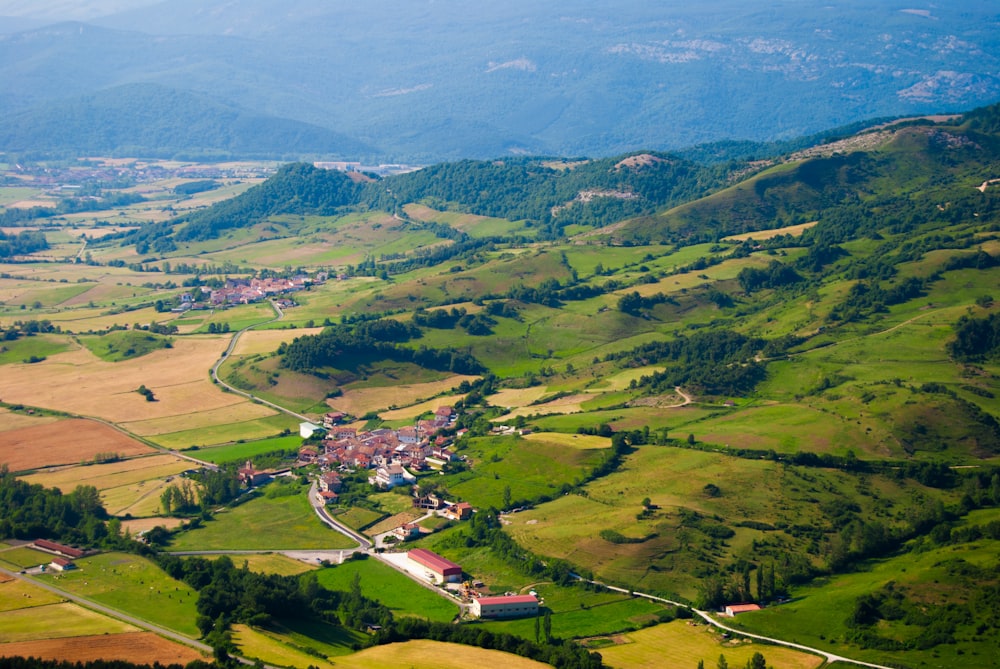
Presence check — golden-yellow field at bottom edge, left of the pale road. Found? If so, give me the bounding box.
[588,620,823,669]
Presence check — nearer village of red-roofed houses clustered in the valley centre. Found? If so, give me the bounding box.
[299,406,466,504]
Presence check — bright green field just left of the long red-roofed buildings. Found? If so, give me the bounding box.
[317,558,458,623]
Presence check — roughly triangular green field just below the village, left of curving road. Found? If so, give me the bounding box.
[170,488,355,551]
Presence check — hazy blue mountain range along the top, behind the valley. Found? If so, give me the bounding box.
[0,0,1000,162]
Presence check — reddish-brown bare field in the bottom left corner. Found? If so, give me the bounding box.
[0,632,209,666]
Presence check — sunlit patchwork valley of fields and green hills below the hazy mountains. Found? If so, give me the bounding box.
[0,107,1000,669]
